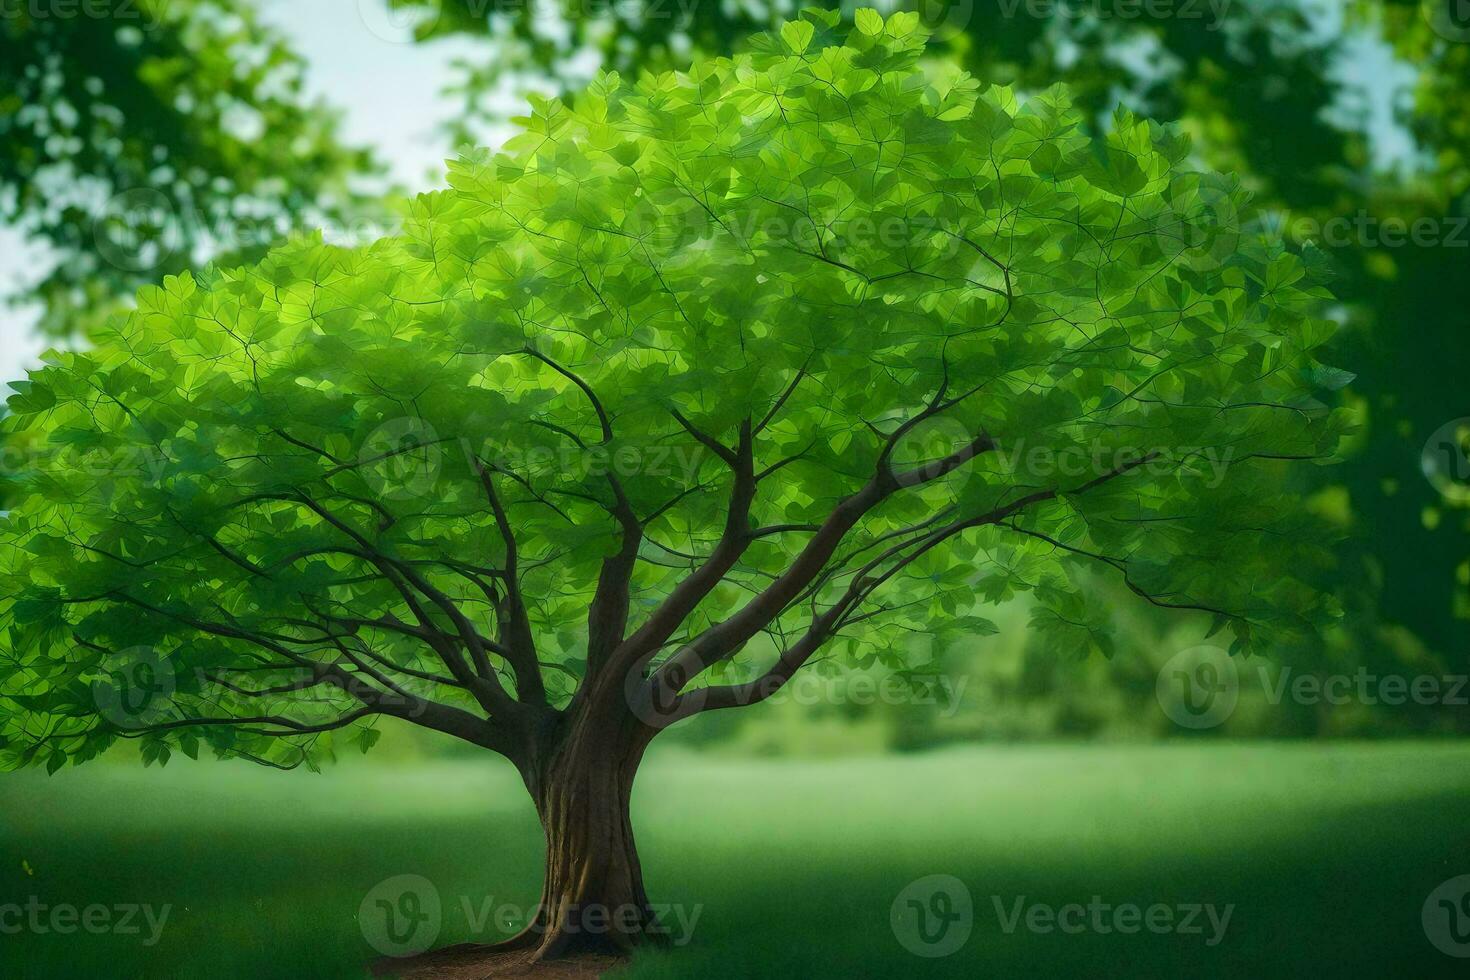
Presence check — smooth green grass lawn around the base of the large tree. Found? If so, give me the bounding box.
[0,742,1470,980]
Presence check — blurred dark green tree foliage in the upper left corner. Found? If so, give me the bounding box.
[0,0,381,334]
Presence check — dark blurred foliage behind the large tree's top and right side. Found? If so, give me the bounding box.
[390,0,1470,670]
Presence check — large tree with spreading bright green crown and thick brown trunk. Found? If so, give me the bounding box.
[0,10,1342,958]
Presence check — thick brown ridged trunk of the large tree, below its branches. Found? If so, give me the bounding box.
[512,708,662,959]
